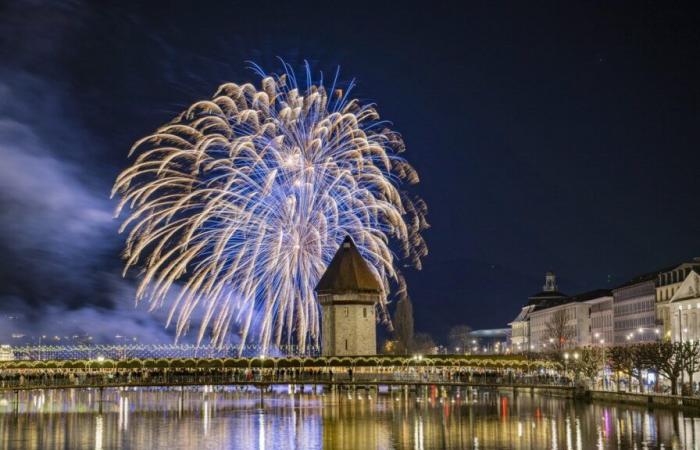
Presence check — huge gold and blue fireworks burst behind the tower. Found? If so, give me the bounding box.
[112,64,427,351]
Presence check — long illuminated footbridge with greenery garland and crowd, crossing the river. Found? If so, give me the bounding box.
[0,355,572,391]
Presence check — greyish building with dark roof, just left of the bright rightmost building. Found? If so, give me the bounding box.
[613,272,661,345]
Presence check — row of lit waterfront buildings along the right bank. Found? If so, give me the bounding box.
[509,258,700,352]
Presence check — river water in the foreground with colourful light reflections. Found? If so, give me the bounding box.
[0,388,700,450]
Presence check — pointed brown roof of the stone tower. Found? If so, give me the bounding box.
[316,236,382,294]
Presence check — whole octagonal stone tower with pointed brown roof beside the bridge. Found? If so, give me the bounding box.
[316,236,383,356]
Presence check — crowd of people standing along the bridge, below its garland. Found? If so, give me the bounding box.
[0,366,572,389]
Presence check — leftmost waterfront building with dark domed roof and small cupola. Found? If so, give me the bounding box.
[508,272,567,353]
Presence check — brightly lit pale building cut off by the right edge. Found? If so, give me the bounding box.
[668,268,700,342]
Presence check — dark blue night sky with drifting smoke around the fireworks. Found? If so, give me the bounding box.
[0,1,700,340]
